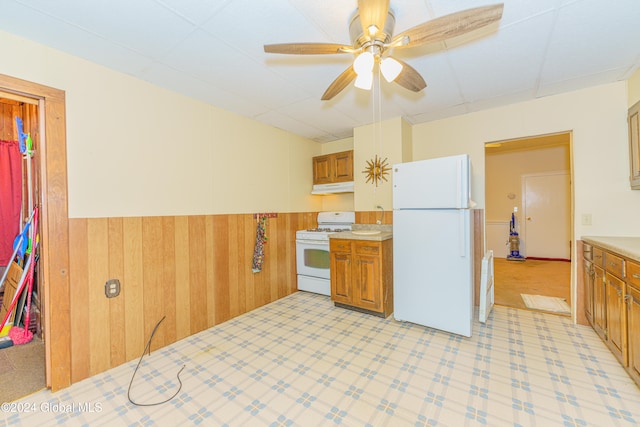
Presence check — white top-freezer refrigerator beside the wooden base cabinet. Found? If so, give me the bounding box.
[392,154,473,337]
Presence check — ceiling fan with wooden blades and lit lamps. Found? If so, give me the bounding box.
[264,0,504,101]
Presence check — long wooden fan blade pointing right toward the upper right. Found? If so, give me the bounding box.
[394,3,504,49]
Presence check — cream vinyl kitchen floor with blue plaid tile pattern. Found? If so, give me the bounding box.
[0,292,640,427]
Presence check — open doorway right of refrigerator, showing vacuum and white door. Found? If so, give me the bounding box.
[485,132,573,315]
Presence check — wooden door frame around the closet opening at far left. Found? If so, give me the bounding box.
[0,74,71,391]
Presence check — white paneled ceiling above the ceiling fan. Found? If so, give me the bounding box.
[0,0,640,142]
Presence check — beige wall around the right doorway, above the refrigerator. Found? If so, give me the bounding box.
[413,82,640,239]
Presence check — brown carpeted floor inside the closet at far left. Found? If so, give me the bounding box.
[0,337,45,403]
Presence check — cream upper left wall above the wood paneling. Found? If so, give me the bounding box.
[0,32,322,218]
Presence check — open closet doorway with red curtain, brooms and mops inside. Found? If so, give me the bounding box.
[0,92,46,402]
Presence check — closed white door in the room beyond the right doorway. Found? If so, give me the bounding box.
[520,171,571,259]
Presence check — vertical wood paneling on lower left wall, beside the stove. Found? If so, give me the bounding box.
[69,213,316,383]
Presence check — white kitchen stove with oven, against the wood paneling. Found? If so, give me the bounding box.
[296,212,356,295]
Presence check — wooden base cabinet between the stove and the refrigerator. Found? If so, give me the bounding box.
[330,239,393,318]
